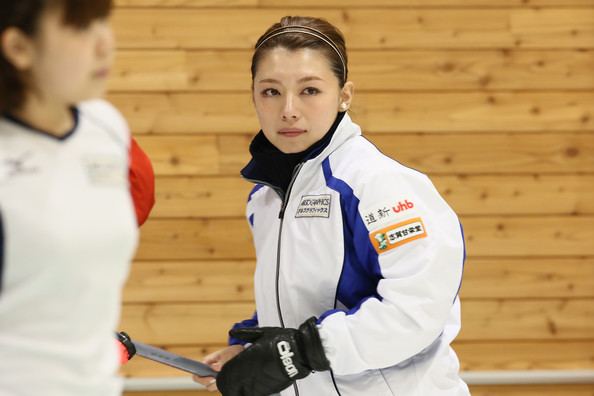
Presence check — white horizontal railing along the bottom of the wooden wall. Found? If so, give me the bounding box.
[125,370,594,392]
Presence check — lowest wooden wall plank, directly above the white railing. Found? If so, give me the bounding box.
[117,340,594,378]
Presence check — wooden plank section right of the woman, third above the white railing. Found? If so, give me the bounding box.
[460,257,594,298]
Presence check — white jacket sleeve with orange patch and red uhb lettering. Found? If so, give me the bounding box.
[318,170,465,375]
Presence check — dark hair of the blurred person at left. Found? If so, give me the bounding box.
[0,0,112,112]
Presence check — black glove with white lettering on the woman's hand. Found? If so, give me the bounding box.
[217,317,330,396]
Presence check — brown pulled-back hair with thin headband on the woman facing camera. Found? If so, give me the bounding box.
[251,16,348,87]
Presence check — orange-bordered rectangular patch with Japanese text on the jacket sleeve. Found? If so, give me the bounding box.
[369,217,427,254]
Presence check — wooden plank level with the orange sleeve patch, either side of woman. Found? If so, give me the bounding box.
[136,216,594,260]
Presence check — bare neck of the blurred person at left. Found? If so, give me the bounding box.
[12,95,74,137]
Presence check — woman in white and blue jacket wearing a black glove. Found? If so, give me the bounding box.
[196,13,469,396]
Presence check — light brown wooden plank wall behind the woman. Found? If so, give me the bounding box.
[109,0,594,396]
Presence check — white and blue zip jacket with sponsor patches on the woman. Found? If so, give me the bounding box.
[236,115,469,396]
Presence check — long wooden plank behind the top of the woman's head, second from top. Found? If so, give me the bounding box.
[113,8,594,49]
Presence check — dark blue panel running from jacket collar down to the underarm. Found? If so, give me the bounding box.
[322,158,383,317]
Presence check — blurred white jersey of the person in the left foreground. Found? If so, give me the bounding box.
[0,101,138,396]
